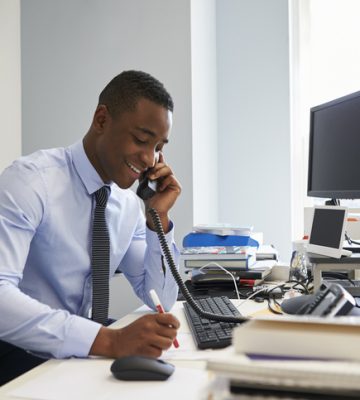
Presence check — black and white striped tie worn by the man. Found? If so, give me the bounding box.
[91,186,110,325]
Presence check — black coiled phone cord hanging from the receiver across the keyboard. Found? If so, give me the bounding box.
[148,208,248,323]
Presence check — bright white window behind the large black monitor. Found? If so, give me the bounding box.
[290,0,360,239]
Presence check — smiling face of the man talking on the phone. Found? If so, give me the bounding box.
[92,99,172,189]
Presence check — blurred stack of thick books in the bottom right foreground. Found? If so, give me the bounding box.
[207,316,360,400]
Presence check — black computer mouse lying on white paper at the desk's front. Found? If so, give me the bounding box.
[111,356,175,381]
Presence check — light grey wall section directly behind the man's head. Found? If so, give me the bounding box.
[21,0,193,316]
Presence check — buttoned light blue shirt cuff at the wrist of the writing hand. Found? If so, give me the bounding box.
[57,315,102,358]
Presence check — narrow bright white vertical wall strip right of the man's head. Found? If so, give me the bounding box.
[191,0,218,224]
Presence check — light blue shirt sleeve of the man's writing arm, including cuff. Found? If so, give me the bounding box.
[0,164,100,358]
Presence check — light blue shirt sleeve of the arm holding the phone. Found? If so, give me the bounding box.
[120,216,180,311]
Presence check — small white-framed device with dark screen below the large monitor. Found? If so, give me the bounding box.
[307,206,351,258]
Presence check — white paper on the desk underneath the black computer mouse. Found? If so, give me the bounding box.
[10,359,208,400]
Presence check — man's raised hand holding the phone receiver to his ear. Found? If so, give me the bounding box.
[145,152,181,233]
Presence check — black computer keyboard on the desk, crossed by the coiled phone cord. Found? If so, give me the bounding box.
[184,296,241,349]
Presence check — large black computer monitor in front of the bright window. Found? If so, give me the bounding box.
[308,91,360,199]
